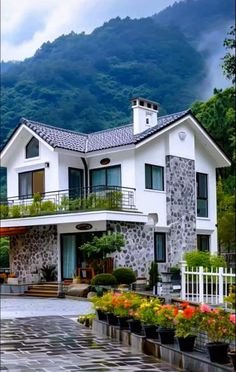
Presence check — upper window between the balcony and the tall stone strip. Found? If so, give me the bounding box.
[145,164,164,191]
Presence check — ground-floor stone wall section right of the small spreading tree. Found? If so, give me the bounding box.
[108,221,154,279]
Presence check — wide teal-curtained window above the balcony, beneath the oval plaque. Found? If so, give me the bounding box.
[90,165,121,187]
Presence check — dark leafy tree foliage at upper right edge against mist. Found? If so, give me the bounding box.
[222,26,236,84]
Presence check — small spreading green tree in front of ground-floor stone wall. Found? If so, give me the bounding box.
[80,233,125,272]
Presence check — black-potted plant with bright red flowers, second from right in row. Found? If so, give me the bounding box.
[174,302,199,351]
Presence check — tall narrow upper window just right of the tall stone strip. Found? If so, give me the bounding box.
[197,173,208,217]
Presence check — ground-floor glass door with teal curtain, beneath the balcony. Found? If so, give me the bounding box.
[61,234,77,279]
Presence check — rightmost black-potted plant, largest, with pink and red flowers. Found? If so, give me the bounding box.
[200,304,235,364]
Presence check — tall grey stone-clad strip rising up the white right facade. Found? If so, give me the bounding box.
[166,155,197,265]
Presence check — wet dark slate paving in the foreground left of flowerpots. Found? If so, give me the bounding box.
[0,316,177,372]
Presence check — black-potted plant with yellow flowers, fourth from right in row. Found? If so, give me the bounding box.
[136,298,161,338]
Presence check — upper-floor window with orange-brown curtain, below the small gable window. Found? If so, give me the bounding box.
[19,169,44,198]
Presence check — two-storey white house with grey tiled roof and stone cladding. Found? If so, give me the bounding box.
[1,98,230,282]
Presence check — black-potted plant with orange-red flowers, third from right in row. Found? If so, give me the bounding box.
[157,305,178,344]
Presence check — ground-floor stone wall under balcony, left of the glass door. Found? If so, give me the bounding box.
[10,225,58,283]
